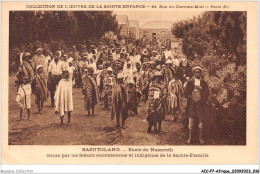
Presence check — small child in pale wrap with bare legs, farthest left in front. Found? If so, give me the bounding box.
[16,76,32,120]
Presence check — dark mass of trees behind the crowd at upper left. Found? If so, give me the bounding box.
[9,11,118,48]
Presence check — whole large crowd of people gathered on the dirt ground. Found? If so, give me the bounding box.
[16,37,208,144]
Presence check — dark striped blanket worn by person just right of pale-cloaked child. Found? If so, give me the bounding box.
[82,75,98,110]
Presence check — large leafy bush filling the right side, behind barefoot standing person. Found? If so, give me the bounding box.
[172,12,246,144]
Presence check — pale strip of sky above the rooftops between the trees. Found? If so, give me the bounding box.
[114,11,202,27]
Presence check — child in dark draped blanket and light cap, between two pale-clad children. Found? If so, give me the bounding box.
[32,65,48,113]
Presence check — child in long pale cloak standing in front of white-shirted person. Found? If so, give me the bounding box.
[54,70,73,125]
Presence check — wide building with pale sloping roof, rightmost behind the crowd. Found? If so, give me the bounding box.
[140,21,176,41]
